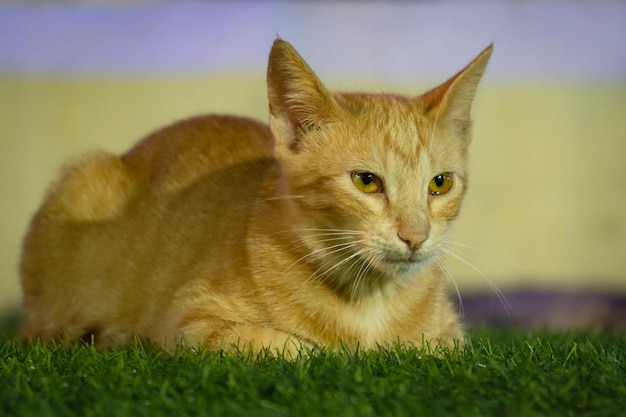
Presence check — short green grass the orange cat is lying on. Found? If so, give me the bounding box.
[0,329,626,417]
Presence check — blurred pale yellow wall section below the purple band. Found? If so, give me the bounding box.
[0,74,626,309]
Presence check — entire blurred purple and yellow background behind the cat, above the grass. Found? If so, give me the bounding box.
[0,1,626,328]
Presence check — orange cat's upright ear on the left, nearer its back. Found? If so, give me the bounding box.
[267,39,339,149]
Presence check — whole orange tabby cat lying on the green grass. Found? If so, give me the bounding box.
[20,39,493,354]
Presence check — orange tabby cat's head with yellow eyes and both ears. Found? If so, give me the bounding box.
[268,39,492,296]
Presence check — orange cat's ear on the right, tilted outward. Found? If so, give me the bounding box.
[419,44,493,134]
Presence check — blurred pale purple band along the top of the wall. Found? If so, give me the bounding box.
[0,1,626,81]
